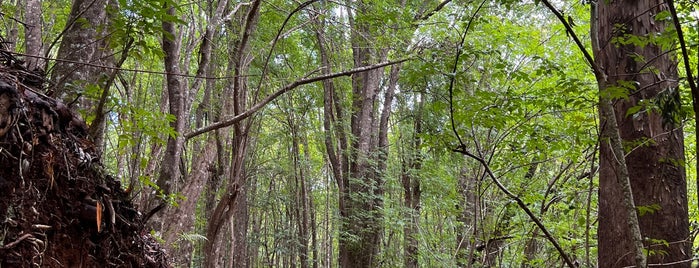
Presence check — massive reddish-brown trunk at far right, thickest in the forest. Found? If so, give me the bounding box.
[593,0,691,267]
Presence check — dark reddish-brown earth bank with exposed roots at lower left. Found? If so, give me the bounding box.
[0,52,171,267]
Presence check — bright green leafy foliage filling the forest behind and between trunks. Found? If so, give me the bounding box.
[2,0,699,267]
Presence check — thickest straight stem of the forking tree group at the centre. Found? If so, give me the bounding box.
[340,2,386,267]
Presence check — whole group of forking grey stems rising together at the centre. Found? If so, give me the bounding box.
[313,1,419,267]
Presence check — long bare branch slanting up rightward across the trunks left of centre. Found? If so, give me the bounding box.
[184,59,408,139]
